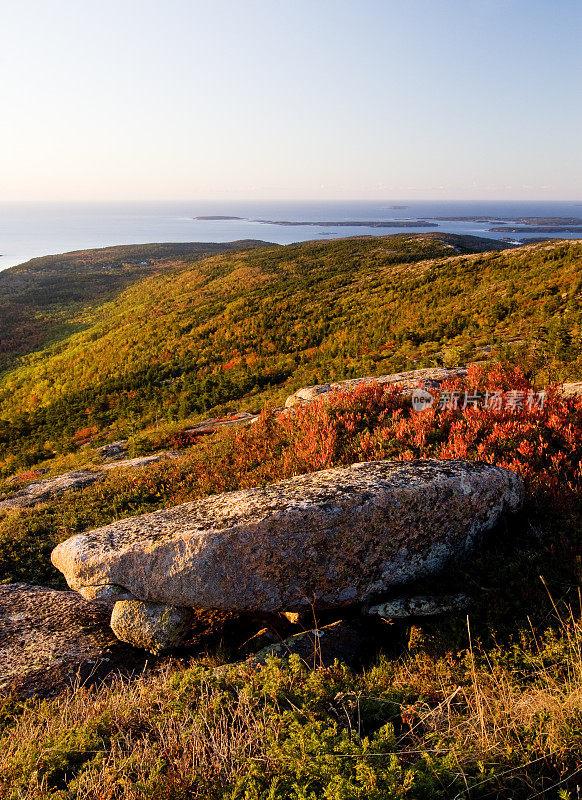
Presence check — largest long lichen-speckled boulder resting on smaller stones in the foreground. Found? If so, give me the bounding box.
[52,459,523,612]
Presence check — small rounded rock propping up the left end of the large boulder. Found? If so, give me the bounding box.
[111,600,194,654]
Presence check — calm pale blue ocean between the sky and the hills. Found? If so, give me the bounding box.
[0,200,582,270]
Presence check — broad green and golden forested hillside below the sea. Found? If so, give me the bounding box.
[0,234,582,474]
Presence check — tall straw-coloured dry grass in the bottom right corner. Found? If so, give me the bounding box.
[400,605,582,799]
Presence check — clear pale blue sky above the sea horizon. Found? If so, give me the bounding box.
[0,0,582,201]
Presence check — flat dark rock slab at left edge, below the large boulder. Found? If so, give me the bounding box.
[0,583,151,697]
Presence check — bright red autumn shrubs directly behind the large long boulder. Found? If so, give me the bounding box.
[208,366,582,510]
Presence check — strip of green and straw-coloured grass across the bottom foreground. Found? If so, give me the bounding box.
[0,612,582,800]
